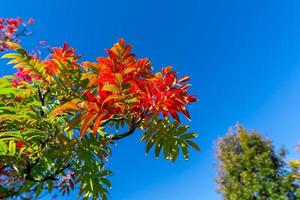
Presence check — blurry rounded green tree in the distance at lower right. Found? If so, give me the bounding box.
[217,125,300,200]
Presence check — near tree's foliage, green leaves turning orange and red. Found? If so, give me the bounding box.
[0,19,199,199]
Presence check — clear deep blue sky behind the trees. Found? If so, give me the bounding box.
[0,0,300,200]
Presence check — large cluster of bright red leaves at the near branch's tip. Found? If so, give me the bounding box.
[79,39,196,136]
